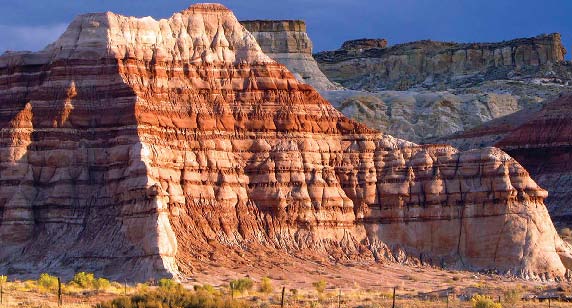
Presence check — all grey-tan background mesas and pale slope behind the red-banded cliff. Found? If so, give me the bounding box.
[241,20,572,143]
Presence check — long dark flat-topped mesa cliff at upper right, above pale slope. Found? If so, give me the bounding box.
[314,33,570,90]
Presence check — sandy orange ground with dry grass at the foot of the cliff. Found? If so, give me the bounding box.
[0,254,572,308]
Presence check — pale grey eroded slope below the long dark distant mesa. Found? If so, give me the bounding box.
[321,90,553,143]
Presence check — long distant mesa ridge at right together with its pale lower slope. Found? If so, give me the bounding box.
[316,34,572,142]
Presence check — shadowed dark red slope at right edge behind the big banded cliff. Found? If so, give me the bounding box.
[441,94,572,226]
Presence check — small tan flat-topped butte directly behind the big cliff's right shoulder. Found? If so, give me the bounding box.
[241,20,337,91]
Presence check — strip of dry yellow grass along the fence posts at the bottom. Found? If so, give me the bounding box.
[1,281,572,308]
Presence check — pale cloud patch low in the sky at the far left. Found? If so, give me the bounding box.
[0,24,67,54]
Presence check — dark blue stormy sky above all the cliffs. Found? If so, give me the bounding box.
[0,0,572,59]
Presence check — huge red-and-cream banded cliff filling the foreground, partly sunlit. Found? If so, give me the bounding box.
[0,4,572,280]
